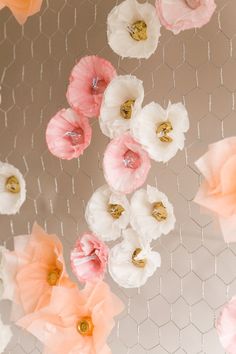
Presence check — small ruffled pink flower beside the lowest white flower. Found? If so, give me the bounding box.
[70,233,109,282]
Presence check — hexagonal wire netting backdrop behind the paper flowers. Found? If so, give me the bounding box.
[0,0,236,354]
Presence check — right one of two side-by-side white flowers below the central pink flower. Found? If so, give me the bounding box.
[130,186,176,241]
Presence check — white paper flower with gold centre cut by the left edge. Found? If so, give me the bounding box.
[0,162,26,215]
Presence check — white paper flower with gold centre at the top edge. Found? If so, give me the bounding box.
[107,0,160,59]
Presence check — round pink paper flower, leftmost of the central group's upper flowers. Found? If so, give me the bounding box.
[46,108,92,160]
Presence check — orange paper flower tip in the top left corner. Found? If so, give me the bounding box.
[0,0,43,25]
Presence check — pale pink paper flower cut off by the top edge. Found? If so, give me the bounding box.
[156,0,216,34]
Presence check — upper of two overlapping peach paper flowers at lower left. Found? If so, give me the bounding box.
[12,224,75,314]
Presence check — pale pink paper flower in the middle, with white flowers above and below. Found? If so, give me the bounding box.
[103,133,151,194]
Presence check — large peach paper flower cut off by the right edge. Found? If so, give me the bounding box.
[195,137,236,242]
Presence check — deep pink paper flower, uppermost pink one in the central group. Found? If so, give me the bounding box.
[67,55,116,117]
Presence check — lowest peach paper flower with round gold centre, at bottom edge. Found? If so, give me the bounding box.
[17,281,123,354]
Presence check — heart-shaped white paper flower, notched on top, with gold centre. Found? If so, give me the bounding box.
[131,102,189,162]
